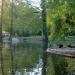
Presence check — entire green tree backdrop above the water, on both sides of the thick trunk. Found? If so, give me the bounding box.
[0,0,75,41]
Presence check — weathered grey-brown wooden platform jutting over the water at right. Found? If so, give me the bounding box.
[47,48,75,58]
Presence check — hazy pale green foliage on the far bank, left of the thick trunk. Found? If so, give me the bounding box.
[3,1,42,36]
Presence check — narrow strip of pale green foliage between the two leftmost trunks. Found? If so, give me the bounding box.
[3,0,11,31]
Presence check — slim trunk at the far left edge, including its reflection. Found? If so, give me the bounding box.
[0,0,4,75]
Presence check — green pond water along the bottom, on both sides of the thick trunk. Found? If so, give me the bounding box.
[0,42,75,75]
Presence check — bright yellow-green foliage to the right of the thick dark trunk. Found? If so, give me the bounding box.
[47,0,75,41]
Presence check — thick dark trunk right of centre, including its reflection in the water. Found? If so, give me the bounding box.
[41,0,48,75]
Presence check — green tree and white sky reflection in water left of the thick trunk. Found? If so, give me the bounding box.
[3,42,43,75]
